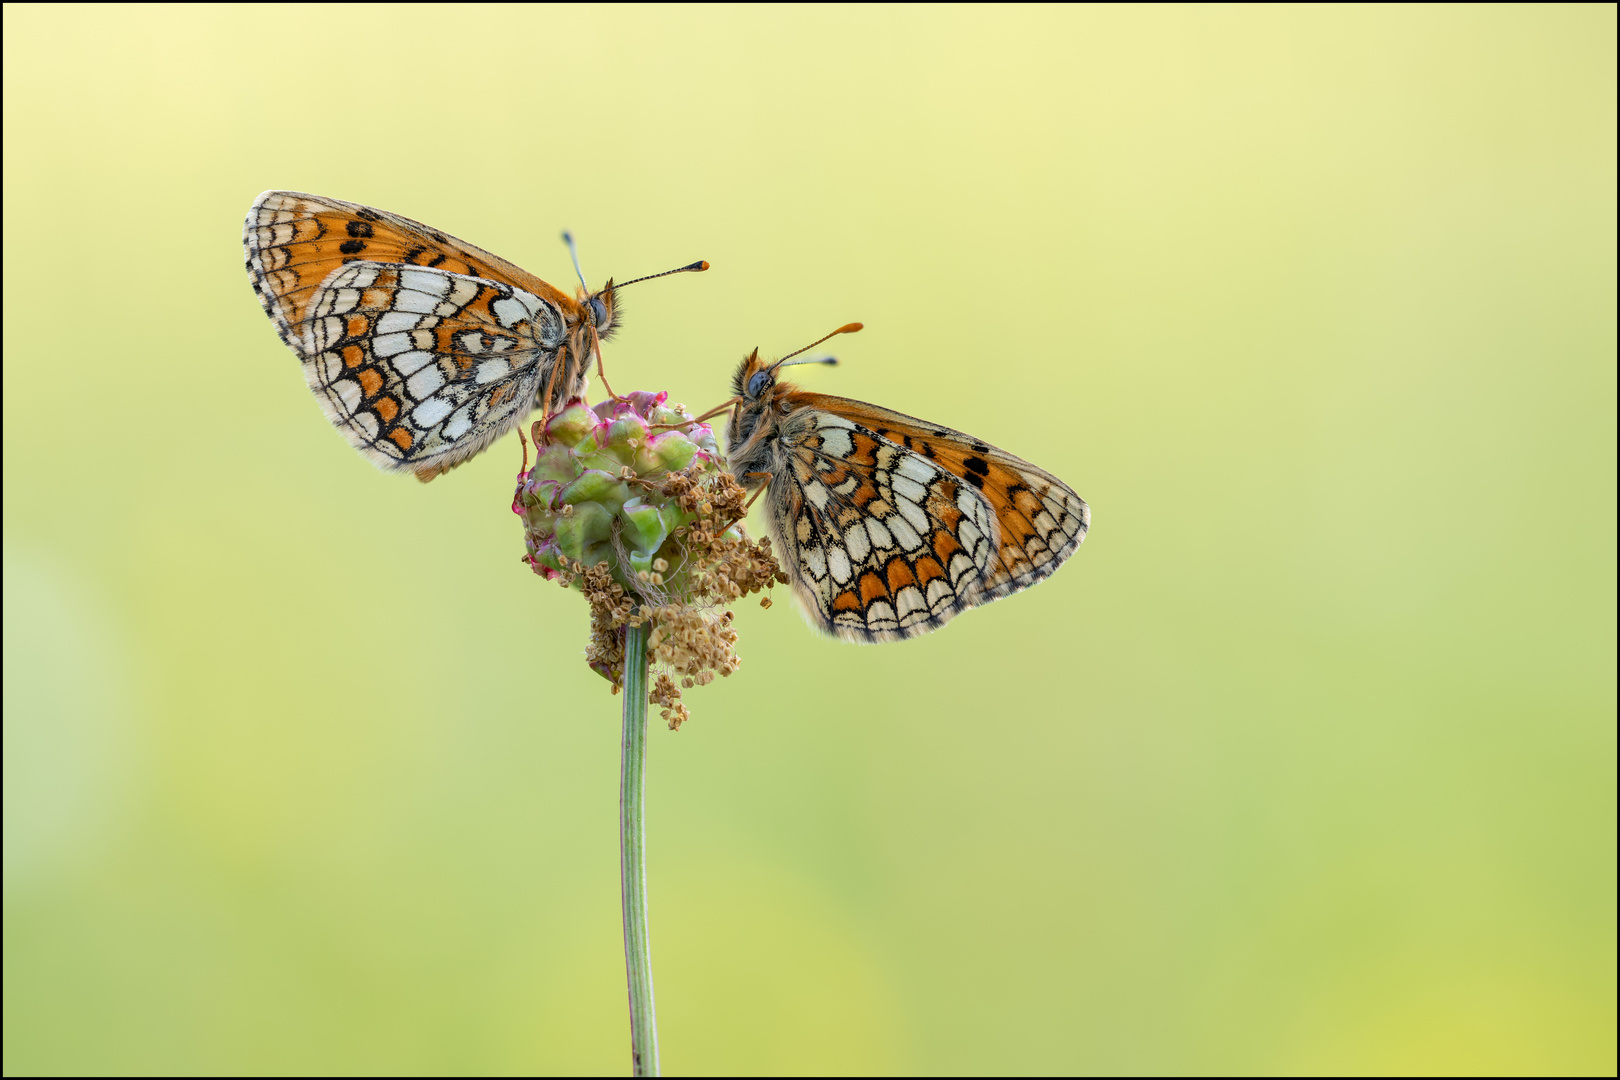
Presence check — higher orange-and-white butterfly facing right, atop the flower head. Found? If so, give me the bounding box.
[241,191,708,481]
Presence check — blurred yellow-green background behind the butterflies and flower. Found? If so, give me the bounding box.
[3,5,1615,1074]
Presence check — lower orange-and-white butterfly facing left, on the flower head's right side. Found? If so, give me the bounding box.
[721,322,1090,641]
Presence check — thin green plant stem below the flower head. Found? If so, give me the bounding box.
[619,625,658,1077]
